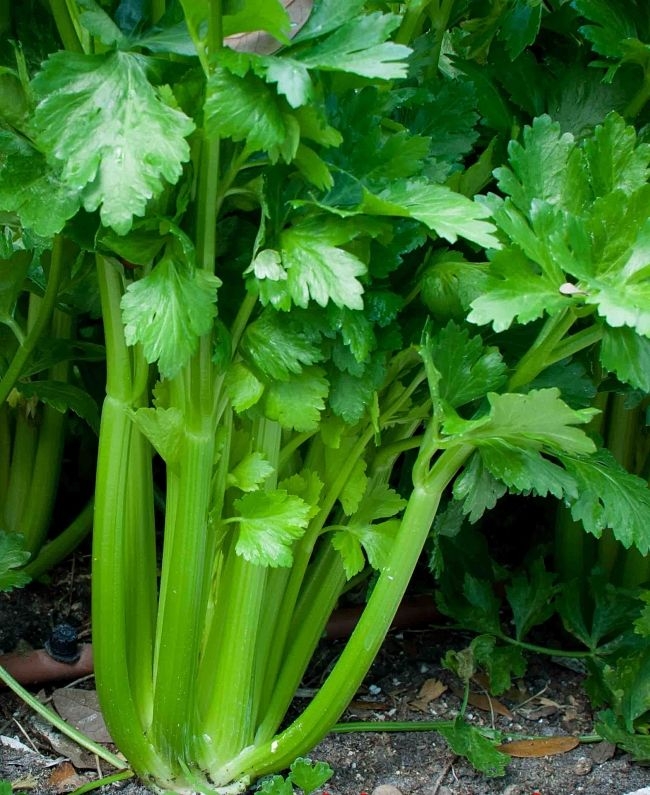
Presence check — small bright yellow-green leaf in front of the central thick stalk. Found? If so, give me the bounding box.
[231,489,309,567]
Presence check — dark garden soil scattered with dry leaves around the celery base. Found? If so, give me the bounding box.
[0,565,650,795]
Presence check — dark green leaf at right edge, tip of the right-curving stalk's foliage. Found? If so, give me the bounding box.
[562,450,650,555]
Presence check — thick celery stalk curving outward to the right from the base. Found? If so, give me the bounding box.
[212,444,474,785]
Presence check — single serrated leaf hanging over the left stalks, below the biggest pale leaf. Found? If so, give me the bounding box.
[121,249,221,378]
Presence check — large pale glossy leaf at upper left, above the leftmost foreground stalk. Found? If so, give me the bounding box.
[33,52,194,234]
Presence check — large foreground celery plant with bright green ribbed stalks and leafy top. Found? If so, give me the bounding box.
[0,0,643,792]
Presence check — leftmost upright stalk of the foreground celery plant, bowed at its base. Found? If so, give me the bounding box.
[92,255,172,782]
